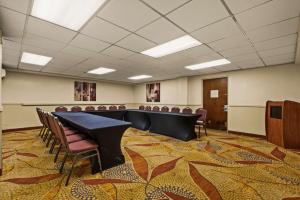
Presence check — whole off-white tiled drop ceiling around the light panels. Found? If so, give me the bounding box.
[0,0,300,83]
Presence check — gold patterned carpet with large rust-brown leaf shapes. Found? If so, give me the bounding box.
[0,129,300,200]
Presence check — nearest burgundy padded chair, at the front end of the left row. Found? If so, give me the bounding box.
[55,118,102,186]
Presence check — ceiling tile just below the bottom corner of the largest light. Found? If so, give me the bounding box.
[70,34,110,52]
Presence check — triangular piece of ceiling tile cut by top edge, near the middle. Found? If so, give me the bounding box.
[142,0,190,14]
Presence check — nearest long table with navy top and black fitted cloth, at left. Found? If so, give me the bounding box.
[53,112,131,174]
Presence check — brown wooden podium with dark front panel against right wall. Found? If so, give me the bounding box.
[266,101,300,149]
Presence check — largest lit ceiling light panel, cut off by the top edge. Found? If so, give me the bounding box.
[31,0,105,31]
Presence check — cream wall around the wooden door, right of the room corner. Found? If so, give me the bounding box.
[134,64,300,135]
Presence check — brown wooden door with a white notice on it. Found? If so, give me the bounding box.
[203,78,228,130]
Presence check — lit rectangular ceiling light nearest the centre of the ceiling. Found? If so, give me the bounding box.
[141,35,202,58]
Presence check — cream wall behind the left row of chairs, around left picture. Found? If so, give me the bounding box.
[2,72,133,129]
